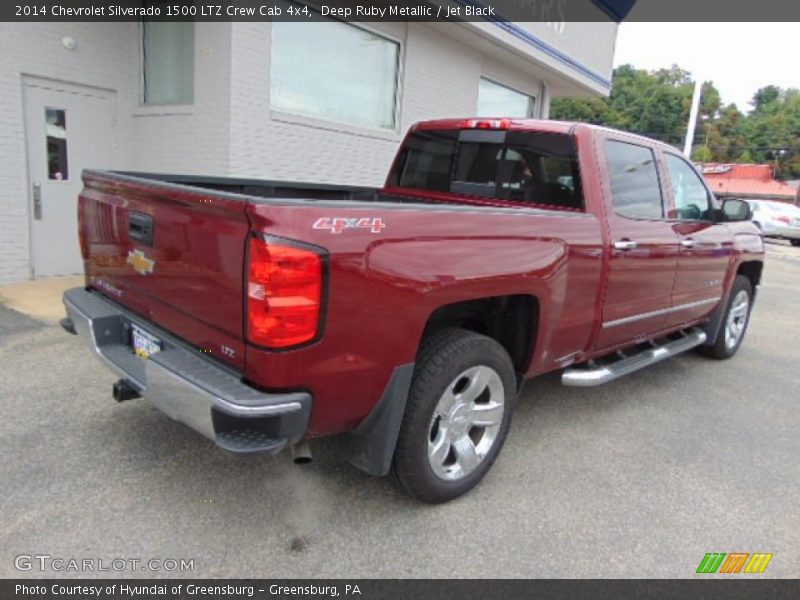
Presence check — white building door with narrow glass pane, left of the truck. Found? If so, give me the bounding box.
[23,78,116,277]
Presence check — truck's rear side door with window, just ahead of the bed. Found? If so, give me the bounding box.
[597,137,679,348]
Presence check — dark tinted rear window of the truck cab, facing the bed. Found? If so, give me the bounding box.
[389,129,583,209]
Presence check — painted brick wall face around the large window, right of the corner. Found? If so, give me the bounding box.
[230,23,541,186]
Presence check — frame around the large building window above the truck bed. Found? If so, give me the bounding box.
[267,14,406,134]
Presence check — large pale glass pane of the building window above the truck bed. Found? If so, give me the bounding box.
[271,21,400,129]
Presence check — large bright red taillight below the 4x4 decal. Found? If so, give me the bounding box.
[247,237,322,348]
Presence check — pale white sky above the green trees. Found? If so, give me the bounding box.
[614,22,800,111]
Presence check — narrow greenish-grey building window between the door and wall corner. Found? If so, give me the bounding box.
[142,21,194,104]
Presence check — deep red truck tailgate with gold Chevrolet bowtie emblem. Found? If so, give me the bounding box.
[79,171,249,368]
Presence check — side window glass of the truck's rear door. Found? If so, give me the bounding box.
[606,140,664,220]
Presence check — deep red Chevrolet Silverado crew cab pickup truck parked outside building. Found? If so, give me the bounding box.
[62,119,764,502]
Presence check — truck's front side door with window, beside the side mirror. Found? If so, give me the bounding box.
[664,152,733,326]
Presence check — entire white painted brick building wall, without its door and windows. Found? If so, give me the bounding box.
[0,23,615,283]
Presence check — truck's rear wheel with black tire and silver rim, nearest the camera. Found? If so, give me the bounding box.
[392,329,517,503]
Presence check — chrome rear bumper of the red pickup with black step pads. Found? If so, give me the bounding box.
[64,288,311,453]
